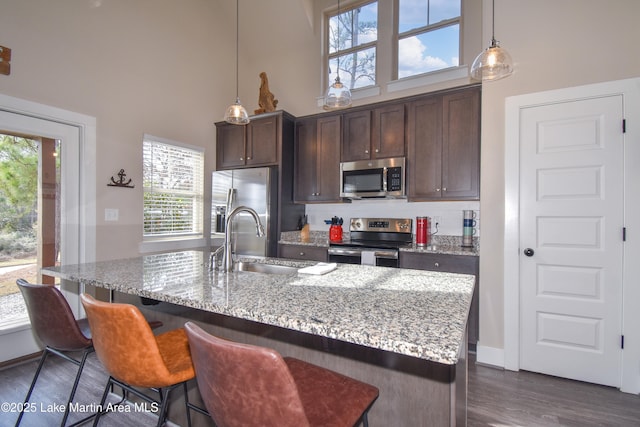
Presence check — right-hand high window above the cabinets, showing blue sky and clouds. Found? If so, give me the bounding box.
[396,0,460,79]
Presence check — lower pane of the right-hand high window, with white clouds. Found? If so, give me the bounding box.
[398,25,460,79]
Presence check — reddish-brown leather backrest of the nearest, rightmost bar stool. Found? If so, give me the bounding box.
[185,322,309,427]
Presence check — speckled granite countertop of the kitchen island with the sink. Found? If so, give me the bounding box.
[43,251,475,365]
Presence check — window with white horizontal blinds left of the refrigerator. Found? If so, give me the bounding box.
[142,135,204,239]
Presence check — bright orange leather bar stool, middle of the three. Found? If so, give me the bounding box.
[80,294,208,427]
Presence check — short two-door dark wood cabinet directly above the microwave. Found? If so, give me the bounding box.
[341,102,405,162]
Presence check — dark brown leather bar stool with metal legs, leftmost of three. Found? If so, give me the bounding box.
[16,279,93,427]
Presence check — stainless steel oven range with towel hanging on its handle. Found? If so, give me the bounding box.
[329,218,413,268]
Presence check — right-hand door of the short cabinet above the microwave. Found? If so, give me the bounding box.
[371,103,405,159]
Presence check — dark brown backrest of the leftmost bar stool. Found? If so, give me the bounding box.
[17,279,91,351]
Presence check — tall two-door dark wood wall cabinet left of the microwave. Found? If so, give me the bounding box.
[294,115,341,203]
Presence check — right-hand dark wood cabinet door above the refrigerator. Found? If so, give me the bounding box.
[246,116,279,166]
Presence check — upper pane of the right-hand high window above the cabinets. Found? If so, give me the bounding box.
[398,0,460,33]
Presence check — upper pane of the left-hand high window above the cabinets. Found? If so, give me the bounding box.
[329,2,378,53]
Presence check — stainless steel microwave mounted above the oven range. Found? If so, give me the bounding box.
[340,157,406,199]
